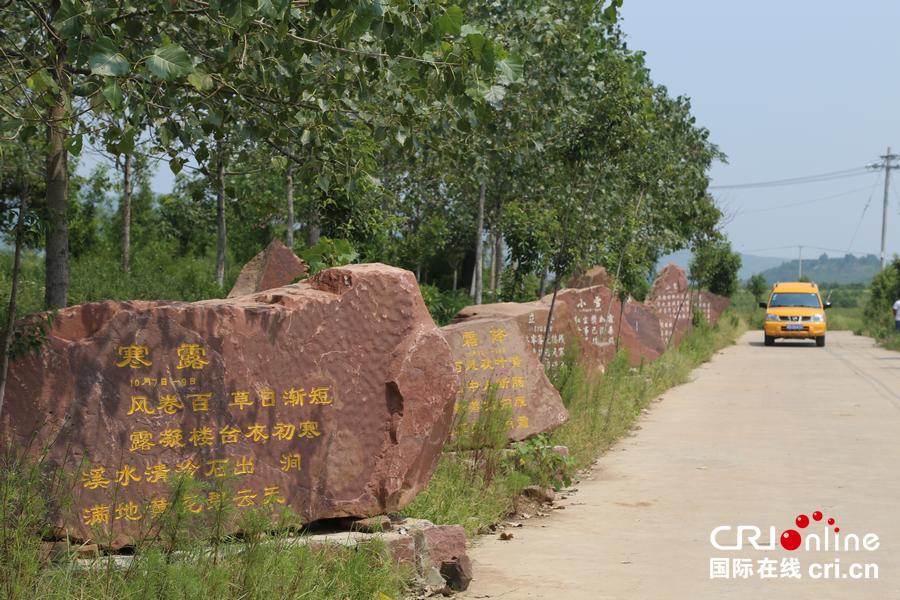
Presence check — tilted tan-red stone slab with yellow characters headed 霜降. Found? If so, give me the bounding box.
[441,318,569,441]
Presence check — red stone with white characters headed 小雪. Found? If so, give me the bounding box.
[541,285,665,366]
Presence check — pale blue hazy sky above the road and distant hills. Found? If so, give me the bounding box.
[621,0,900,258]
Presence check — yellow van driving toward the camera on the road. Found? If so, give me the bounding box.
[759,282,831,347]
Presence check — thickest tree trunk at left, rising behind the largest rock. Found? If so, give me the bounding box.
[44,43,69,310]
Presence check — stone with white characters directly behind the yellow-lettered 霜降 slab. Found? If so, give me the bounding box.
[451,302,614,372]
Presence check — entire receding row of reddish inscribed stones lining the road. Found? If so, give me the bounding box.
[0,240,728,549]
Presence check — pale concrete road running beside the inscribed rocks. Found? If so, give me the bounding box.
[465,332,900,600]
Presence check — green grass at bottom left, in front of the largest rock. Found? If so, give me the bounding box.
[0,440,411,600]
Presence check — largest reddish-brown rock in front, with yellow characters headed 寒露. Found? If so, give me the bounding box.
[0,264,458,548]
